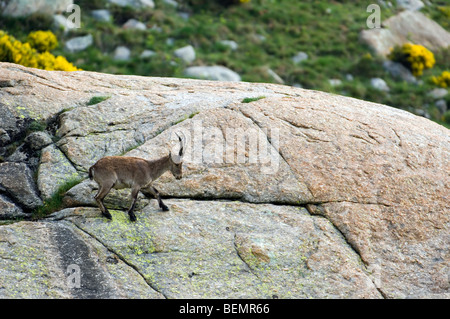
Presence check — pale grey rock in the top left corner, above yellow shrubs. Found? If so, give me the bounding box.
[0,0,73,17]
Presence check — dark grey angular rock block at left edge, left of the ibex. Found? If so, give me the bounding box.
[0,162,43,213]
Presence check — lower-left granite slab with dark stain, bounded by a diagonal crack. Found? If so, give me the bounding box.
[0,221,163,299]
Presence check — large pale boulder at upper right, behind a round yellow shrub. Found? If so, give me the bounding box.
[360,10,450,56]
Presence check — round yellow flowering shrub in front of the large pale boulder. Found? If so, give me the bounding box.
[388,43,436,76]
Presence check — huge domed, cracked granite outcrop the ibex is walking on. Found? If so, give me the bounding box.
[0,63,450,298]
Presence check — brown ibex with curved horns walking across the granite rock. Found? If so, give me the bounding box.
[89,134,184,221]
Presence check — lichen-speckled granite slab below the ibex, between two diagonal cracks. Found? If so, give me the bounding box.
[65,199,380,298]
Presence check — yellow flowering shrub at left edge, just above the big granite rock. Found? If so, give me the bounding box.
[0,30,80,71]
